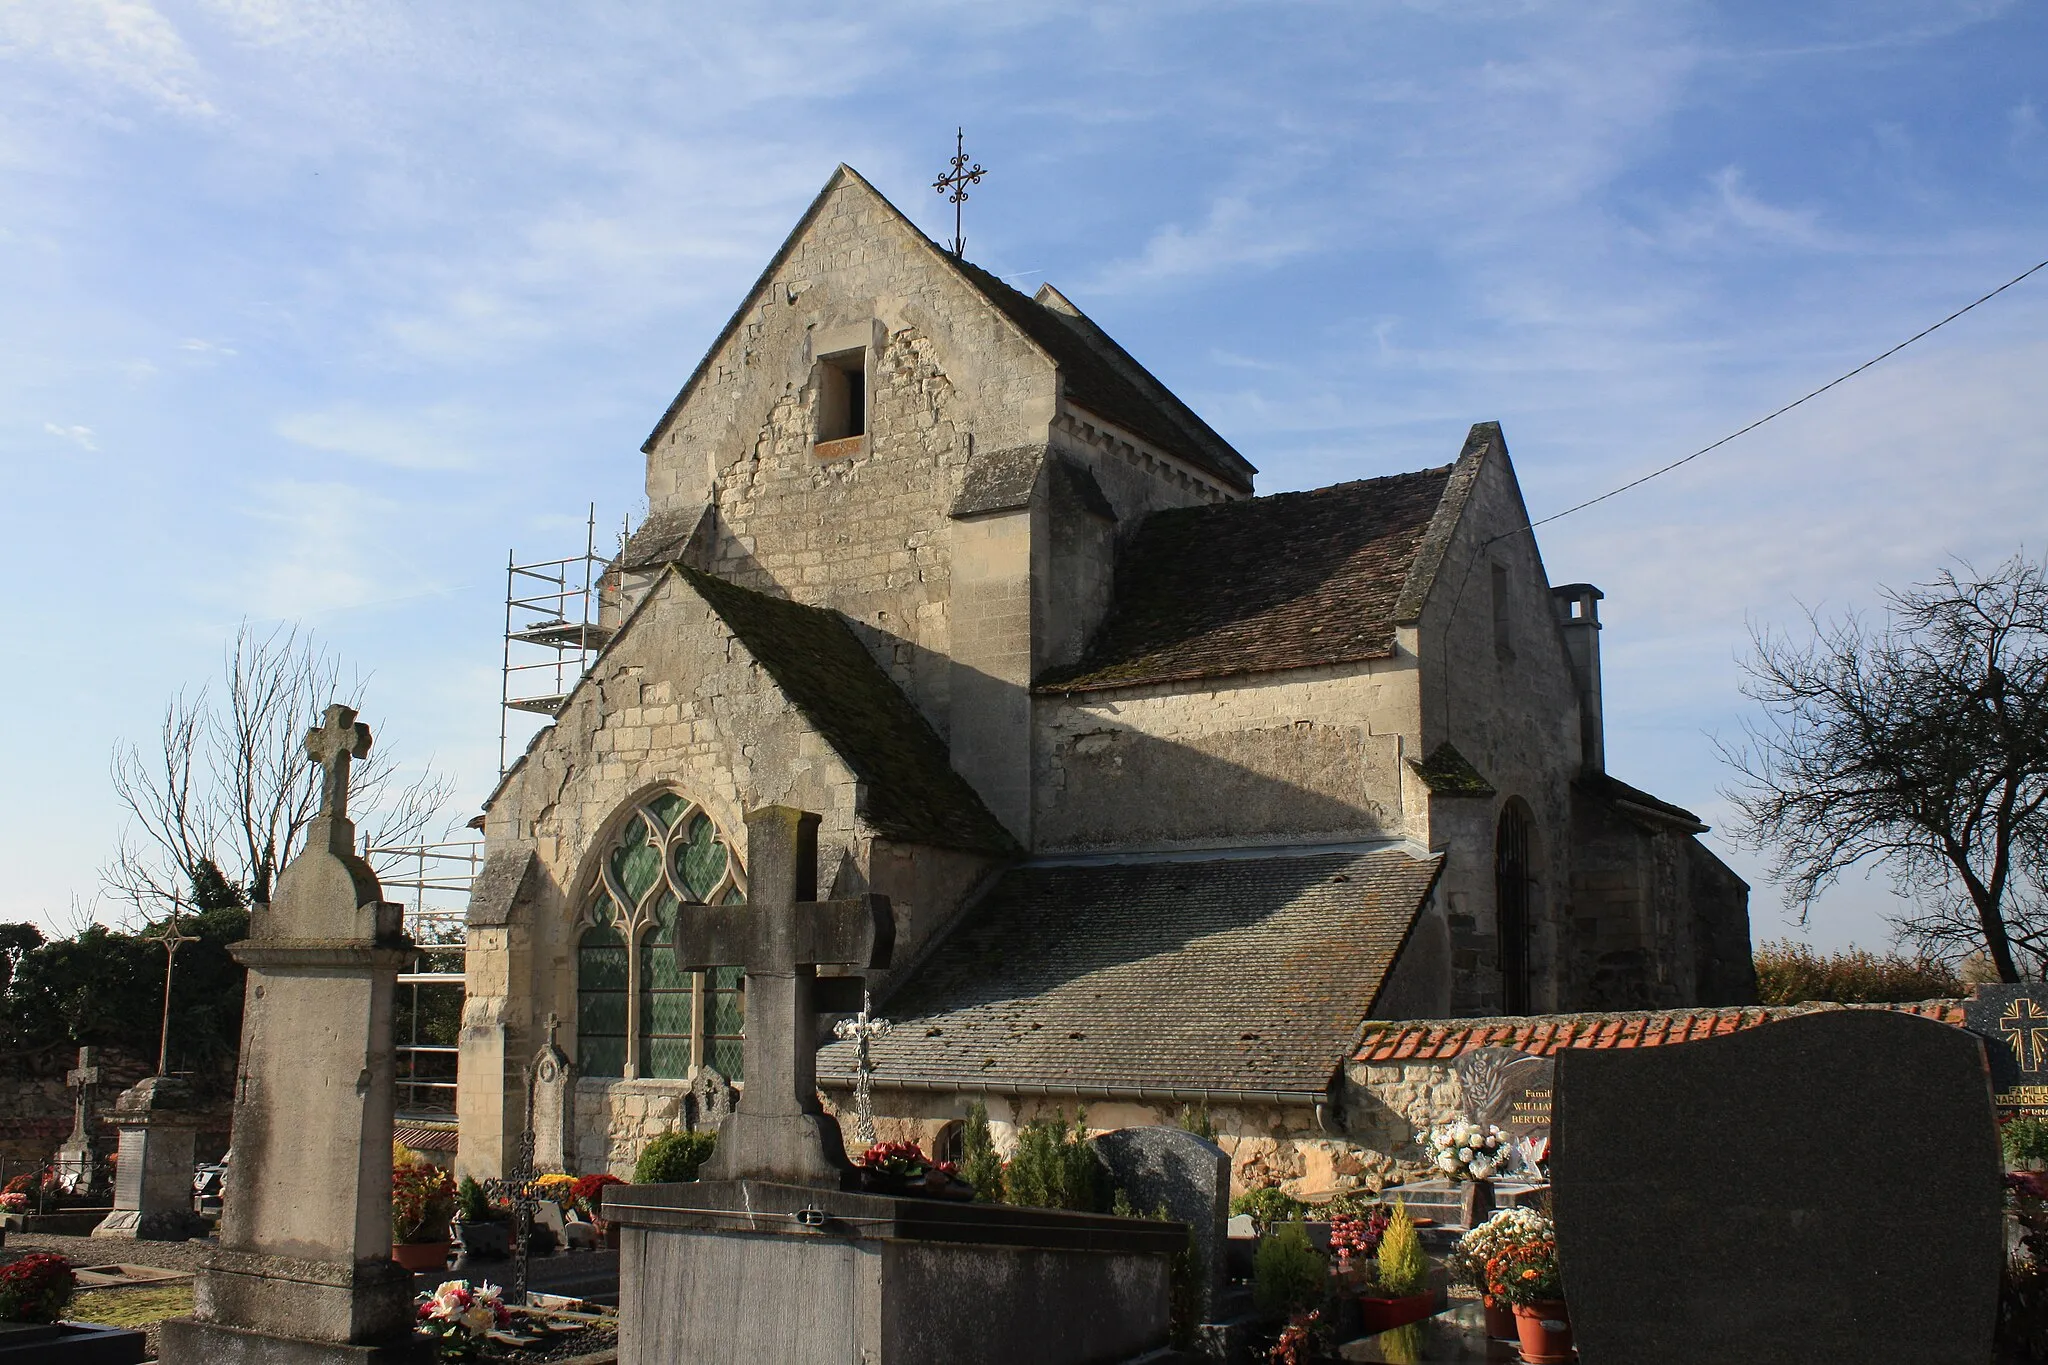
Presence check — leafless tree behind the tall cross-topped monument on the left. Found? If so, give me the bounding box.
[102,624,455,919]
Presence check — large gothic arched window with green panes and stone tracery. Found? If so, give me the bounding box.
[575,792,748,1081]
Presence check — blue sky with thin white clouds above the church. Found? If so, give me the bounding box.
[0,0,2048,948]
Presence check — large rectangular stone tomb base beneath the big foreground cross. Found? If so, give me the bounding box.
[604,1181,1188,1365]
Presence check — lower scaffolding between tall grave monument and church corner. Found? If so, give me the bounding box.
[362,839,483,1124]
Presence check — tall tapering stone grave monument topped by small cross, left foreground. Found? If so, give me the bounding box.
[162,706,423,1365]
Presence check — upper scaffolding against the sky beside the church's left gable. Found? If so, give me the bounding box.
[498,503,612,778]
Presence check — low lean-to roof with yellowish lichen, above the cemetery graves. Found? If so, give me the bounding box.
[819,849,1442,1099]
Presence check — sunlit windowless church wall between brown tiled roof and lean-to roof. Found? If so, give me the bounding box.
[1032,657,1427,849]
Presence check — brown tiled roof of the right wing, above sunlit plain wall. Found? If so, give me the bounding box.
[1040,465,1456,692]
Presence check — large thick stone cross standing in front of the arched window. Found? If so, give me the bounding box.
[676,806,895,1187]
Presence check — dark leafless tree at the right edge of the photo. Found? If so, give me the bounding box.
[1722,555,2048,980]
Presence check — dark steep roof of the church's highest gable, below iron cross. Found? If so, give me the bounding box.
[641,164,1257,493]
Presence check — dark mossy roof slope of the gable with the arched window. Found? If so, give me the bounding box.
[676,565,1016,853]
